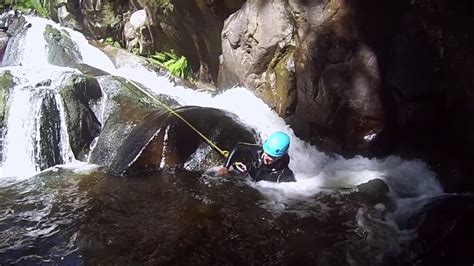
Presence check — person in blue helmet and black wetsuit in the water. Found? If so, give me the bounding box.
[219,131,296,182]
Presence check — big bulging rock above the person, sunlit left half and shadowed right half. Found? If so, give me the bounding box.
[220,0,385,154]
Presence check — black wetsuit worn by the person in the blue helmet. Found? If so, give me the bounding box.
[225,142,296,182]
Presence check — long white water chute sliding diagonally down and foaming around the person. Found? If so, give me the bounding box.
[0,17,442,206]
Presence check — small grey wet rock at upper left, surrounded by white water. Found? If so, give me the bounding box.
[43,25,82,68]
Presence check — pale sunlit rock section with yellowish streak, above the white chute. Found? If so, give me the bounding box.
[219,1,296,116]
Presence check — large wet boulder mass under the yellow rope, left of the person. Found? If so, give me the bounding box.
[89,76,256,175]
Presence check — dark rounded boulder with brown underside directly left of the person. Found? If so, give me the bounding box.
[126,106,257,176]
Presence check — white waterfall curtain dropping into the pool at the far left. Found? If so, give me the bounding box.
[1,67,75,178]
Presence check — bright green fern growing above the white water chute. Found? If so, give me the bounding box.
[149,52,193,79]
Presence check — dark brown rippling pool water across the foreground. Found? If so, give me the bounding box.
[0,166,470,265]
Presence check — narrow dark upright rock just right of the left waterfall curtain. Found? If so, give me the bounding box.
[59,74,103,160]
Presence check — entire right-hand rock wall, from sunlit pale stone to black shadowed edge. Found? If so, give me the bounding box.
[219,0,474,158]
